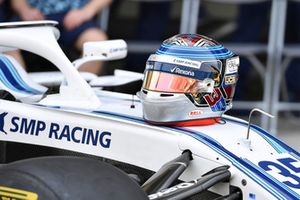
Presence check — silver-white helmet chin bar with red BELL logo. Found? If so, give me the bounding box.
[138,89,224,126]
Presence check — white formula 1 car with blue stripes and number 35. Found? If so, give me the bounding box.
[0,21,300,200]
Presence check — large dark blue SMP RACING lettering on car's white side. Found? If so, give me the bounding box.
[0,113,112,148]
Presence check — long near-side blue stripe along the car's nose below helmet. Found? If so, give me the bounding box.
[88,111,300,199]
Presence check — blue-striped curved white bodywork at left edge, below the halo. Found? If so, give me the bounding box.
[0,56,44,94]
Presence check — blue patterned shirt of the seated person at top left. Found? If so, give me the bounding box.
[27,0,89,15]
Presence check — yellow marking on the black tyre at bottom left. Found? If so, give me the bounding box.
[0,186,38,200]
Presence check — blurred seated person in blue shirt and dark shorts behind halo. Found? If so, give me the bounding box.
[11,0,111,74]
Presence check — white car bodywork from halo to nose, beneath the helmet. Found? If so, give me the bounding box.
[0,21,300,200]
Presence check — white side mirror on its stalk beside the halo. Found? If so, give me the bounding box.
[73,40,127,68]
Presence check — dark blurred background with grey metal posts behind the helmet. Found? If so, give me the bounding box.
[2,0,300,150]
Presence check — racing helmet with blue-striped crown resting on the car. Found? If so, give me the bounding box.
[138,34,239,126]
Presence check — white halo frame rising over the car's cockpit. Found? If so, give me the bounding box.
[0,21,100,108]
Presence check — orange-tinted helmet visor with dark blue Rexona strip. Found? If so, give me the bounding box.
[143,55,222,93]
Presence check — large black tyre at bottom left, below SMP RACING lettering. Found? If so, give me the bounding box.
[0,156,148,200]
